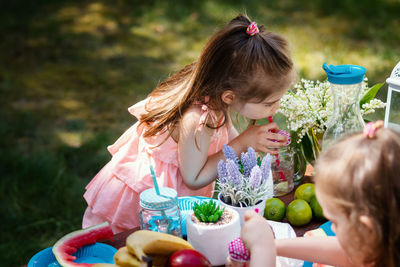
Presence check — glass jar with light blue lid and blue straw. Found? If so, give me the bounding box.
[139,166,182,237]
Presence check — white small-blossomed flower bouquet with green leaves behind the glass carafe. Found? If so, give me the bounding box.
[278,78,385,163]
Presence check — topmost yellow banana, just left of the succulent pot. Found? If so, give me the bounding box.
[126,230,194,259]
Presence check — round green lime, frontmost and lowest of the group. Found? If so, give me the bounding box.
[286,199,312,226]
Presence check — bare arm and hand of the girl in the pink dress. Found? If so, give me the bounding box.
[178,108,286,189]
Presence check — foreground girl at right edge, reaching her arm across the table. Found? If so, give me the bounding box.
[242,121,400,267]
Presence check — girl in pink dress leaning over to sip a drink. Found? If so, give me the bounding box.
[82,15,294,233]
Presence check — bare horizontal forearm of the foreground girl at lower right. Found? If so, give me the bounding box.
[275,236,352,266]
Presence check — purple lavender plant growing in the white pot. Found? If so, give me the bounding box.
[217,145,274,207]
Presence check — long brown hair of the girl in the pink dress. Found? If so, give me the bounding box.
[140,15,293,140]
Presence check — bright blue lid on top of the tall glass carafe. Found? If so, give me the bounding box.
[322,63,367,84]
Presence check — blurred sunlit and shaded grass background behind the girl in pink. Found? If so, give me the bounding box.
[0,0,400,266]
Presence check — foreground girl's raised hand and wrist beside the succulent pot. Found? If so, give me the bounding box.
[241,211,276,267]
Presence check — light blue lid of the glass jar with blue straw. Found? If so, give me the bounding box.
[140,187,178,210]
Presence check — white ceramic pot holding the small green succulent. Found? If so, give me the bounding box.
[186,207,240,266]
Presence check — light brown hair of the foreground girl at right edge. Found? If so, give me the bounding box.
[315,128,400,266]
